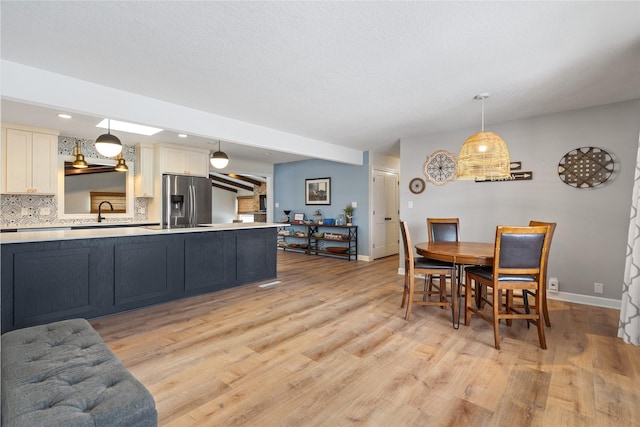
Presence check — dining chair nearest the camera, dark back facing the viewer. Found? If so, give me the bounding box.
[465,225,550,349]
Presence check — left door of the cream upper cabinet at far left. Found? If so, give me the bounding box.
[2,129,32,193]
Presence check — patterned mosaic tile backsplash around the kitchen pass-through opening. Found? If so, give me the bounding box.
[0,136,148,228]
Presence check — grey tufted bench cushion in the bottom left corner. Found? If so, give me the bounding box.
[0,319,158,427]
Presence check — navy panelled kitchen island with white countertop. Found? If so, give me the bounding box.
[0,223,281,333]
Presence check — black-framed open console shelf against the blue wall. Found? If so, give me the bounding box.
[278,224,358,261]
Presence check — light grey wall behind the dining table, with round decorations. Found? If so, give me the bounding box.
[400,100,640,299]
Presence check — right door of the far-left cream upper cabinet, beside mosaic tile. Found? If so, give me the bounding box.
[31,132,58,194]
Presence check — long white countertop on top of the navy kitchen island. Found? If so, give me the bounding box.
[0,222,288,245]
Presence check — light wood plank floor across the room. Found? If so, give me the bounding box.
[91,252,640,427]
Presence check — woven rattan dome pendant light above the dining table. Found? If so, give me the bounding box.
[457,93,511,181]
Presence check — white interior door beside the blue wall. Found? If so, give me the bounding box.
[372,170,400,259]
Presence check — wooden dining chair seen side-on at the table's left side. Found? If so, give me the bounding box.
[400,221,457,328]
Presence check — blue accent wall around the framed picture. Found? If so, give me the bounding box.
[273,151,371,256]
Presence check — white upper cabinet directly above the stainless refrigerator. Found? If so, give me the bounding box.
[156,145,209,177]
